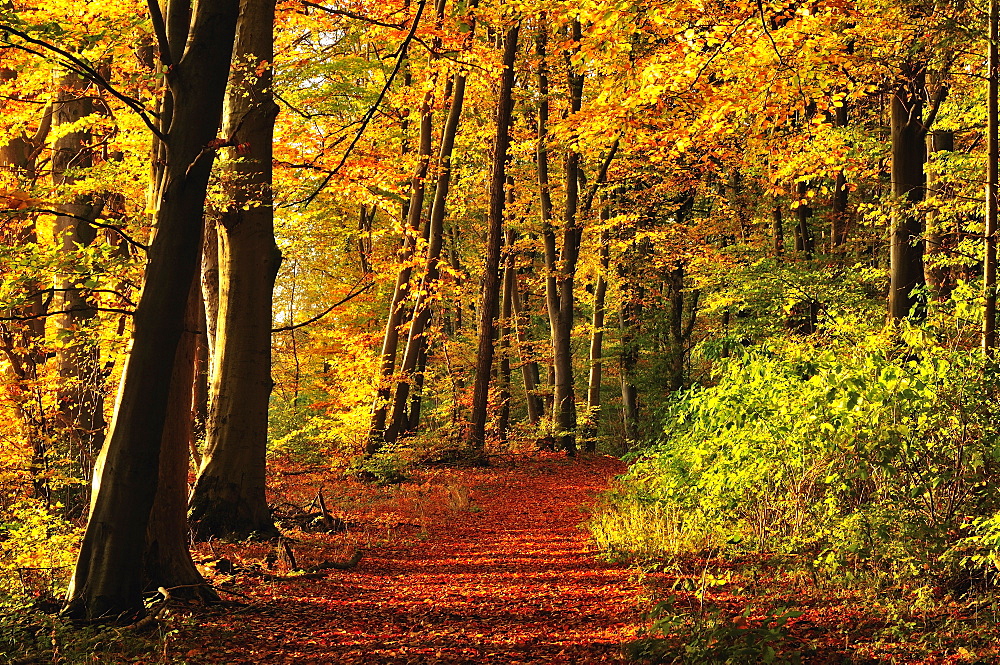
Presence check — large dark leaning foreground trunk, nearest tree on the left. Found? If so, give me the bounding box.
[66,0,239,621]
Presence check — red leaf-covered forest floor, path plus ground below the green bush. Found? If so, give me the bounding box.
[150,453,1000,665]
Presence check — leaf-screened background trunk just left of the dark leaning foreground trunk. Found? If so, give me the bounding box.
[52,73,106,496]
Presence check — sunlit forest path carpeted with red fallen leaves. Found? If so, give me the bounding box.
[191,455,639,665]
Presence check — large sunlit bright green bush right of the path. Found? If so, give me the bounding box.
[592,326,1000,578]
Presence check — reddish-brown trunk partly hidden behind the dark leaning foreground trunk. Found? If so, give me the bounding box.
[143,280,219,601]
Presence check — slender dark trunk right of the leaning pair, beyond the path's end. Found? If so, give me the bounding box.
[469,25,520,451]
